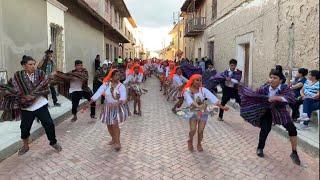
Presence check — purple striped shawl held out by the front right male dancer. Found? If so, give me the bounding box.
[239,84,295,127]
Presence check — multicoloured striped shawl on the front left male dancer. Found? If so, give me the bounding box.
[0,70,49,121]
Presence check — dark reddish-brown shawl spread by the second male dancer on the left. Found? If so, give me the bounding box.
[54,69,92,99]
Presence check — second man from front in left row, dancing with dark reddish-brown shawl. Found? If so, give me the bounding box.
[55,60,96,122]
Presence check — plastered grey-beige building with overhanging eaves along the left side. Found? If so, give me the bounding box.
[0,0,140,82]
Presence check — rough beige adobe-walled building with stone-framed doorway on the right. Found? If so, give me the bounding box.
[181,0,319,87]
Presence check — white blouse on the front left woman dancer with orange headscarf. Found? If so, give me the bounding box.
[91,83,127,103]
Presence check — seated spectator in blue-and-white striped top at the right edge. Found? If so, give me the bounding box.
[298,70,320,130]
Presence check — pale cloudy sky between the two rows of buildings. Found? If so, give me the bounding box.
[124,0,185,51]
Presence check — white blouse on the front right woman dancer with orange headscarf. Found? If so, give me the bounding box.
[183,87,219,107]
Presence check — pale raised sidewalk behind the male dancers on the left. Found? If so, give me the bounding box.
[0,95,85,162]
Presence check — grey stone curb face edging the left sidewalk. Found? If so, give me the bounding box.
[0,102,85,162]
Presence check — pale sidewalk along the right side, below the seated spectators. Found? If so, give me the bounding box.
[217,87,319,157]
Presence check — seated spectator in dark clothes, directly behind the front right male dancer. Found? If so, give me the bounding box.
[290,68,308,121]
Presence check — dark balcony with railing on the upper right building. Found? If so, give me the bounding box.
[184,17,206,37]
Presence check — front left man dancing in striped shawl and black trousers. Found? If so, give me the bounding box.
[0,56,62,155]
